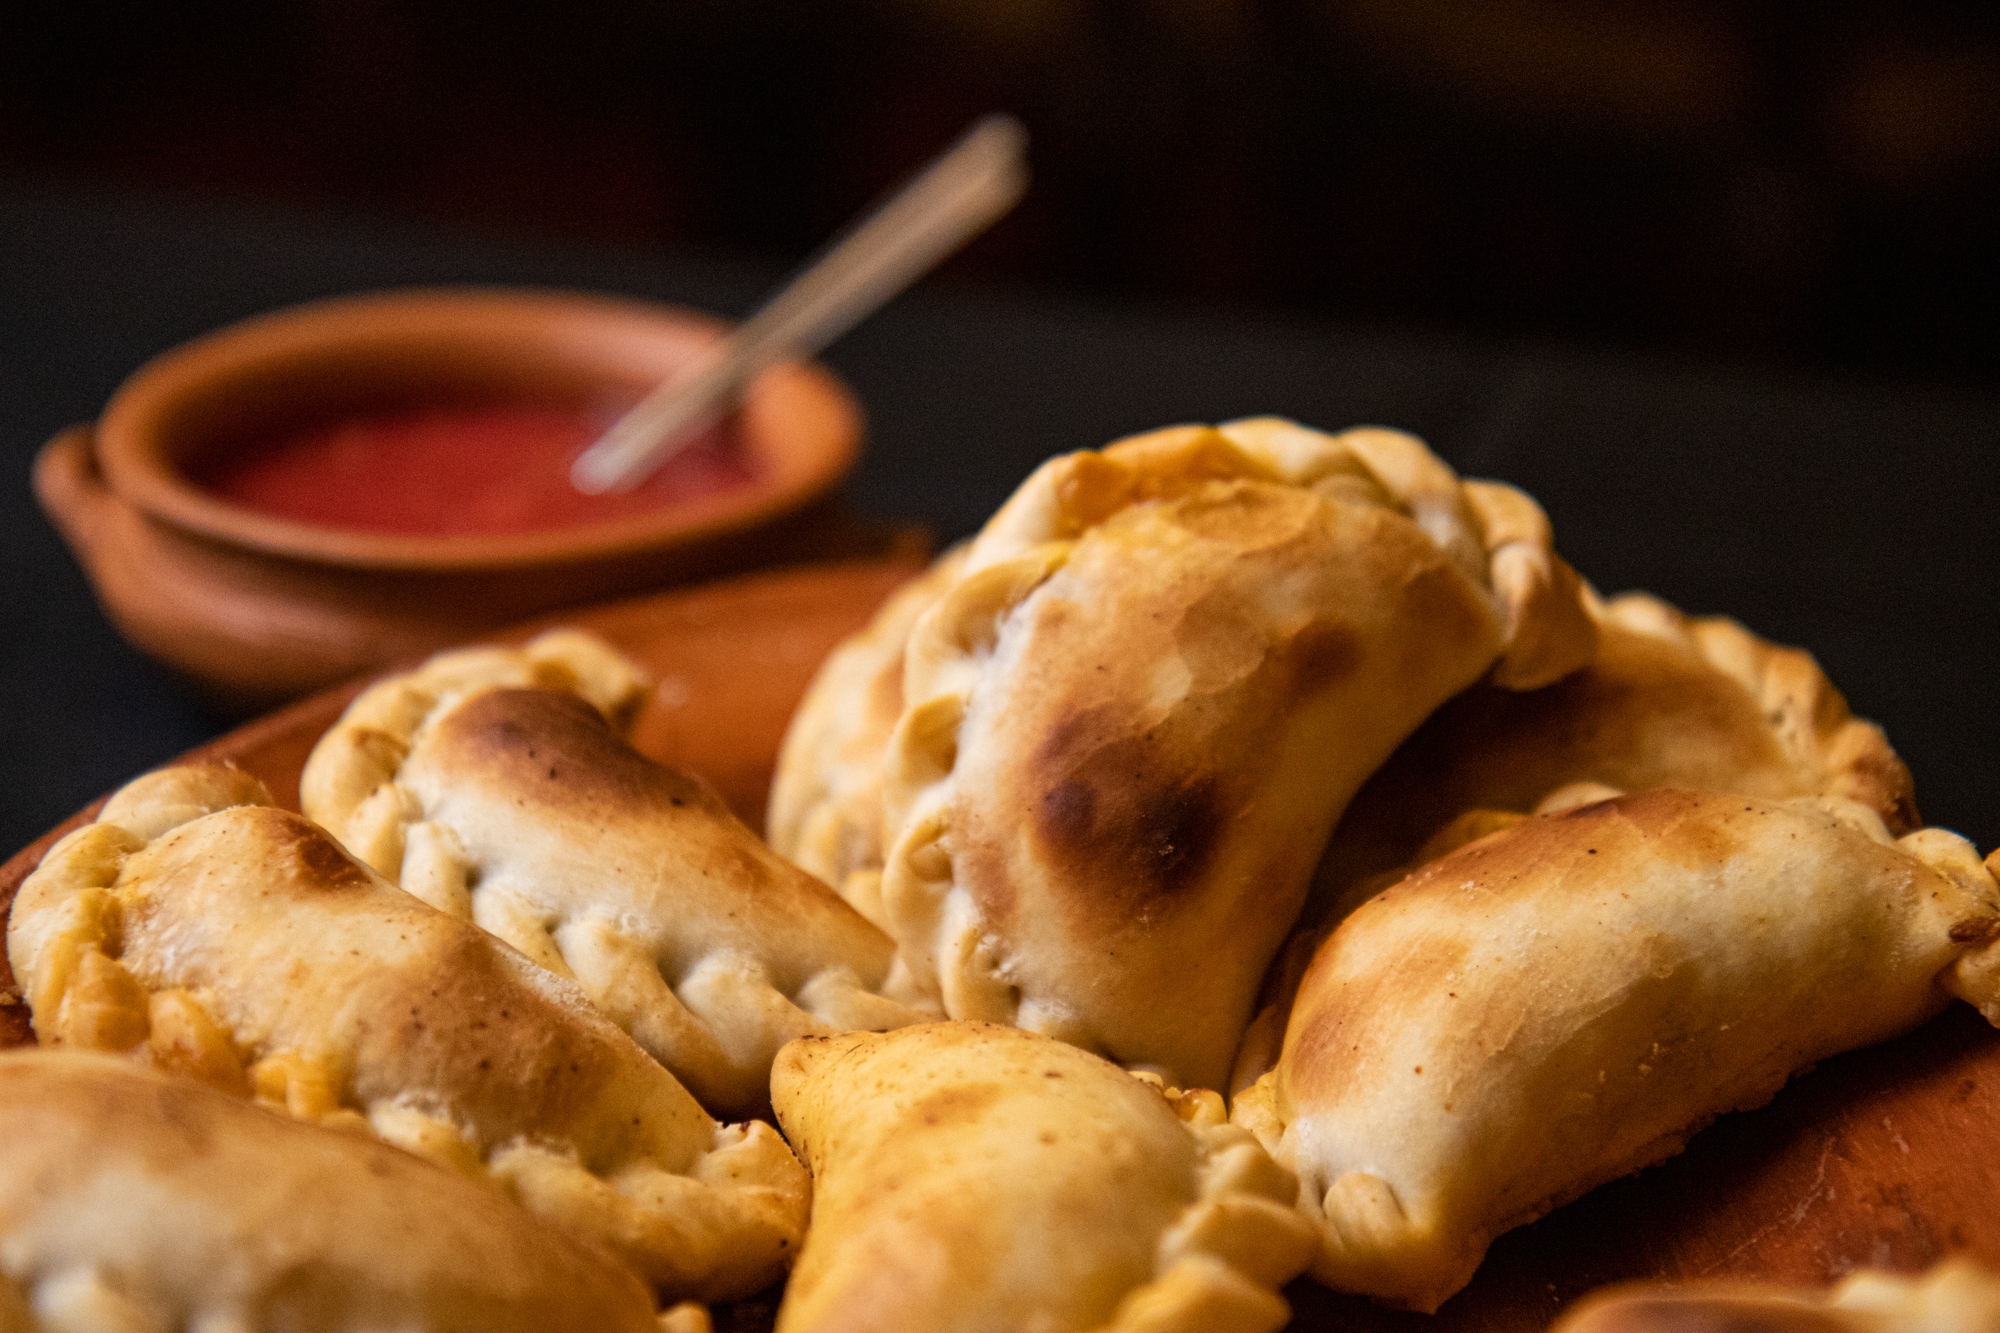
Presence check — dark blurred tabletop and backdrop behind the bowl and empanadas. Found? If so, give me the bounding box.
[0,0,2000,853]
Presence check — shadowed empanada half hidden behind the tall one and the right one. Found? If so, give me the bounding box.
[1230,592,1920,1091]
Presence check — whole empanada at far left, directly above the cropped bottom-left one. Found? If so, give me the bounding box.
[8,769,808,1299]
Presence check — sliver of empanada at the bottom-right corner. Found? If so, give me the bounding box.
[1552,1259,2000,1333]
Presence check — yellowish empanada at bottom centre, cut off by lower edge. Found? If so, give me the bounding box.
[772,1023,1314,1333]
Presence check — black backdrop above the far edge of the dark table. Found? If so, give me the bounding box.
[11,0,2000,380]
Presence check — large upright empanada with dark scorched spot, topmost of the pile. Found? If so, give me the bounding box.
[882,418,1596,1087]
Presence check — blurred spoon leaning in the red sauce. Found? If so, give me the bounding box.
[570,114,1028,494]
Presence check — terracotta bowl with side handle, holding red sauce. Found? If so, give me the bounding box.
[34,288,866,711]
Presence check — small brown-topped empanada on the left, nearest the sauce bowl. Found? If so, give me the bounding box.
[300,632,936,1117]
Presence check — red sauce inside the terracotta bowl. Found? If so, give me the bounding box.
[196,406,750,536]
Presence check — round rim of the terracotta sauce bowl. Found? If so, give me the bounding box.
[96,286,864,572]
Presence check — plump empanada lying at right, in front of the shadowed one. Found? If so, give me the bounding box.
[1234,789,2000,1311]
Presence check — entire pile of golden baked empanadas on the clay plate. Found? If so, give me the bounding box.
[0,418,2000,1333]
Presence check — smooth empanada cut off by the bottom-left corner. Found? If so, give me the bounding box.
[0,1051,654,1333]
